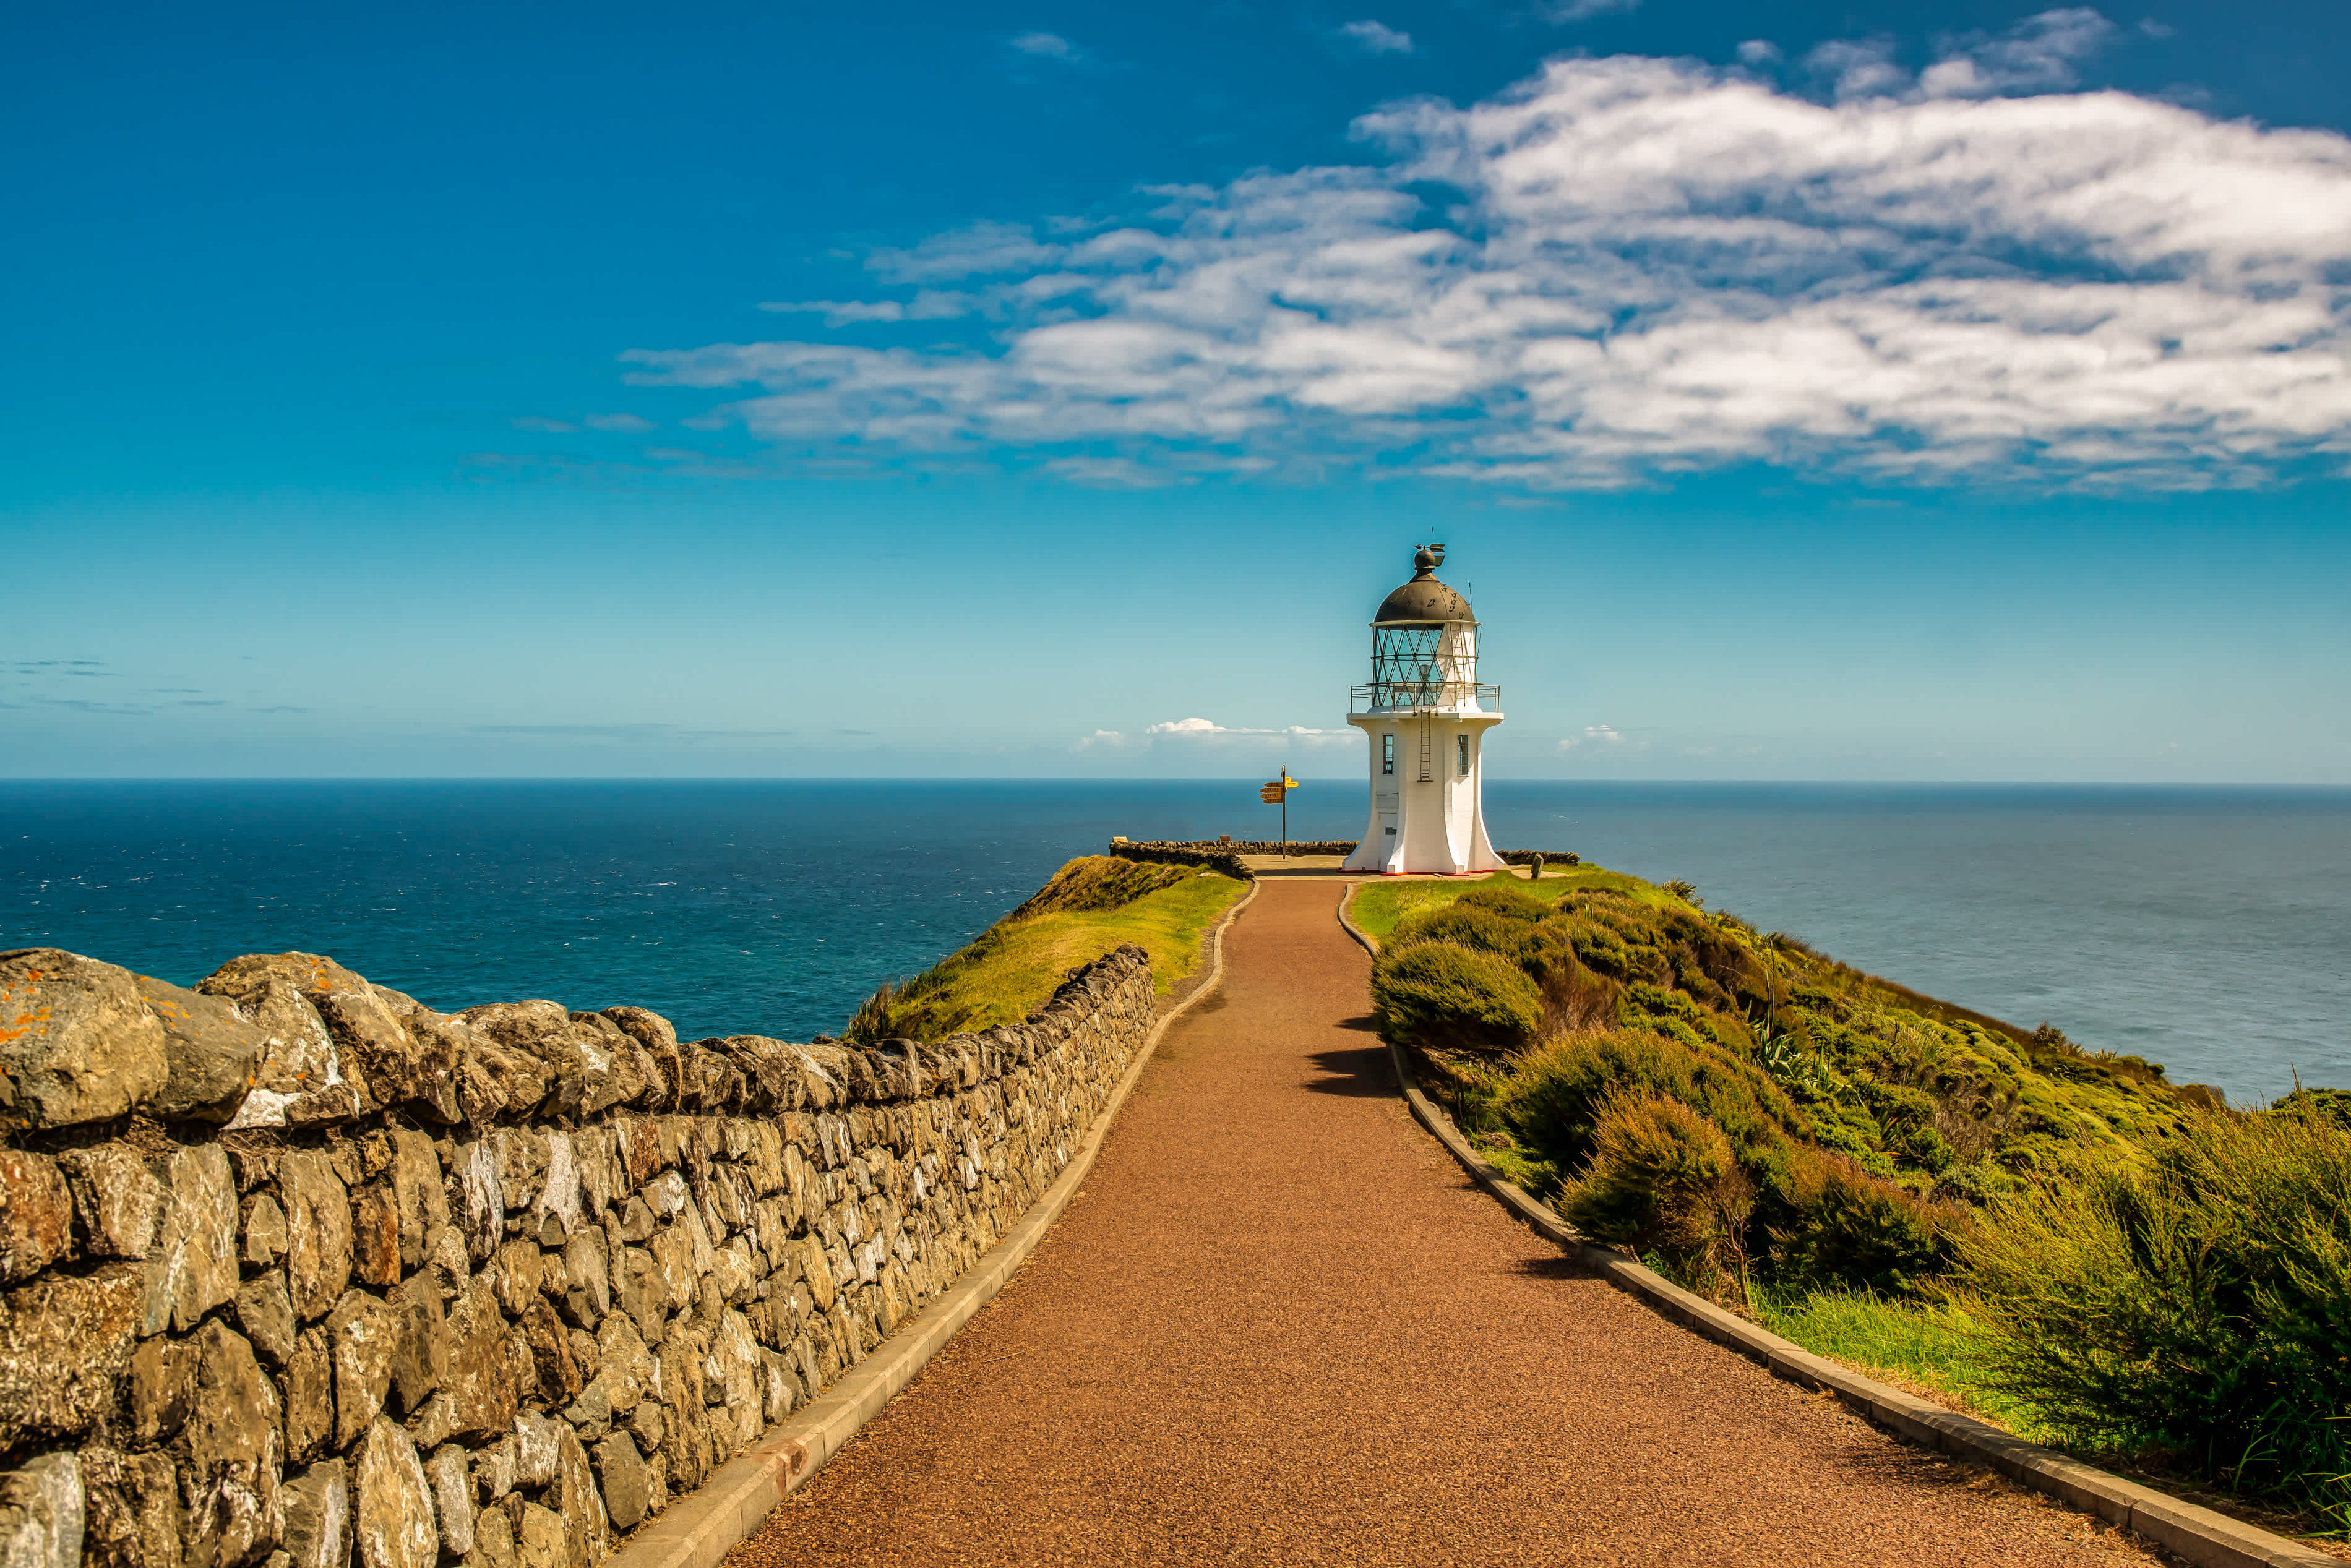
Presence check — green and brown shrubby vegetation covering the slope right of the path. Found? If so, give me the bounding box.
[1352,867,2351,1533]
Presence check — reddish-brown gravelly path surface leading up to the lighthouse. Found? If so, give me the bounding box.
[731,881,2151,1568]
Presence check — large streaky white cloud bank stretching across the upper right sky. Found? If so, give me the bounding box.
[625,21,2351,489]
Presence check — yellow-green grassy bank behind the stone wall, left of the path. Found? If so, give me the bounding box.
[841,855,1249,1043]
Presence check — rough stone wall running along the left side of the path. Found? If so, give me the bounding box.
[0,948,1154,1568]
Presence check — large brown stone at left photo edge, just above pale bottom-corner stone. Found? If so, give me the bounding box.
[0,1262,146,1446]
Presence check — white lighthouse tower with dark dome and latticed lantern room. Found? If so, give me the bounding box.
[1345,546,1502,877]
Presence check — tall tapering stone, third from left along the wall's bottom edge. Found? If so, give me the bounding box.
[181,1321,285,1568]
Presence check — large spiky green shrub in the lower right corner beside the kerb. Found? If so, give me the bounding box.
[1954,1112,2351,1526]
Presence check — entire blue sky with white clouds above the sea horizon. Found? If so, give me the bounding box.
[0,0,2351,785]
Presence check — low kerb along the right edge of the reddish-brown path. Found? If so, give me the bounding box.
[1338,881,2342,1568]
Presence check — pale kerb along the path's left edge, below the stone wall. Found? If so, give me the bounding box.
[602,881,1258,1568]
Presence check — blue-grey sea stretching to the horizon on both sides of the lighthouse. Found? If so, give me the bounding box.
[0,781,2351,1100]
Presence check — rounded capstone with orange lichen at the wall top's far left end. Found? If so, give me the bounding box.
[0,948,165,1128]
